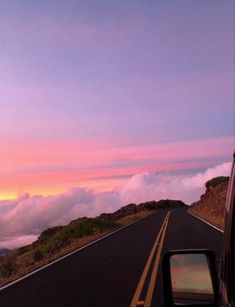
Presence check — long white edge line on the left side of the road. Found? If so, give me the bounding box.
[0,213,151,291]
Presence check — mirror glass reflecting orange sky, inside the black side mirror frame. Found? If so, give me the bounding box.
[170,254,215,305]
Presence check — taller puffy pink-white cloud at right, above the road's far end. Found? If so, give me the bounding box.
[118,162,232,204]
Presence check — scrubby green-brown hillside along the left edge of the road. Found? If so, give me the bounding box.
[0,200,185,285]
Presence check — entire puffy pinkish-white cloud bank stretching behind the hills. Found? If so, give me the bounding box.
[0,162,231,248]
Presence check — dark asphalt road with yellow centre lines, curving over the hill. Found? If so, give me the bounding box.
[0,209,223,307]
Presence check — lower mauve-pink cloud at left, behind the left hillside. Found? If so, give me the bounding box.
[0,188,120,248]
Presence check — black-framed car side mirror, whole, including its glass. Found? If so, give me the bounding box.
[162,250,219,307]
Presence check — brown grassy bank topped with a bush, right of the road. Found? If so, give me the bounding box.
[189,177,229,230]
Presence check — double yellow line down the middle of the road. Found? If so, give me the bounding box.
[130,212,170,307]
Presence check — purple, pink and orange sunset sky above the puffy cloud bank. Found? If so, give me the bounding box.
[0,0,234,249]
